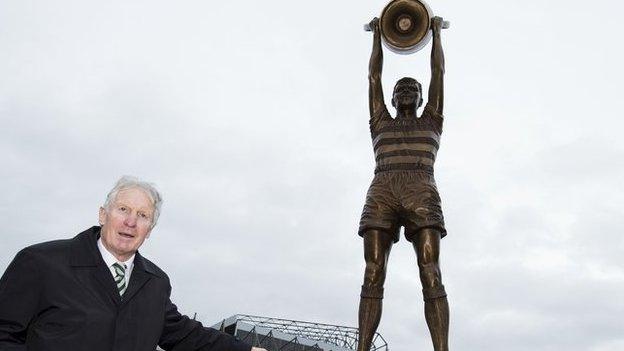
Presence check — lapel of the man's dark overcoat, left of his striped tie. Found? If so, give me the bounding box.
[70,227,121,305]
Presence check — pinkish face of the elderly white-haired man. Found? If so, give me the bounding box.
[99,188,154,261]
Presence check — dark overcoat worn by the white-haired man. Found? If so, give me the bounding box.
[0,227,250,351]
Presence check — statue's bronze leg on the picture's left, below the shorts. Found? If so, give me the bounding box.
[357,229,393,351]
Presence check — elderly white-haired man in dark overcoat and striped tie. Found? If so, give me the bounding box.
[0,177,263,351]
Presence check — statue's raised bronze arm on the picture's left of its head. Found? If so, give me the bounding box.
[368,17,385,119]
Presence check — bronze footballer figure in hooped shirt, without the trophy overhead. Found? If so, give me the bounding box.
[358,13,449,351]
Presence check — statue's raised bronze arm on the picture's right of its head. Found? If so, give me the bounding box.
[427,16,444,115]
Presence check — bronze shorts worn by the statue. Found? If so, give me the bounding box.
[358,171,446,242]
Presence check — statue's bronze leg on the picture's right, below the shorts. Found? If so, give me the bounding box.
[412,228,449,351]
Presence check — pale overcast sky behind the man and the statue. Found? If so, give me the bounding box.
[0,0,624,351]
